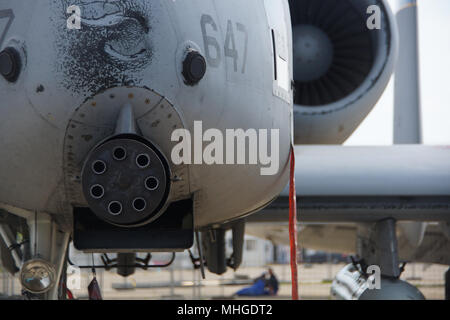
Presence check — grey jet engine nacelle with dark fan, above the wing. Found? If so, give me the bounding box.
[289,0,398,144]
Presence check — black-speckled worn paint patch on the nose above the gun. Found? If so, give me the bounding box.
[56,1,153,93]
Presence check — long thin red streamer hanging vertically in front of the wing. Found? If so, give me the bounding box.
[289,146,298,300]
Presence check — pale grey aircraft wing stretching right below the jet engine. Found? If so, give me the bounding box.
[247,145,450,222]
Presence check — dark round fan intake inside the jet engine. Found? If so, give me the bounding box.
[292,0,375,106]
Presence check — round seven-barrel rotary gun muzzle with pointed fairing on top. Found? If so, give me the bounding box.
[81,105,170,227]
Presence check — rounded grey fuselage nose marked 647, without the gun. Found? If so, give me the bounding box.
[0,0,292,228]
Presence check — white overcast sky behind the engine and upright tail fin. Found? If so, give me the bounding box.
[346,0,450,145]
